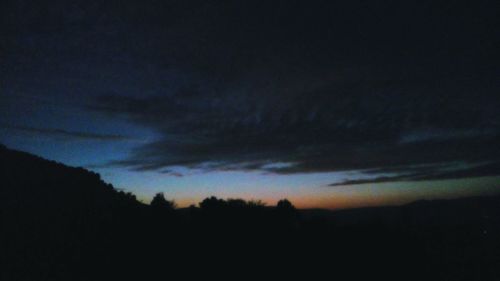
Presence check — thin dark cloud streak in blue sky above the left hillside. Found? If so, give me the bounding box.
[0,126,131,141]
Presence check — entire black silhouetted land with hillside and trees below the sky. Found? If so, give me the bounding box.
[0,144,500,280]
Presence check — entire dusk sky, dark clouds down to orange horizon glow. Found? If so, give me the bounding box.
[0,0,500,206]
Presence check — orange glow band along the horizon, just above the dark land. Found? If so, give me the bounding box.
[140,177,500,210]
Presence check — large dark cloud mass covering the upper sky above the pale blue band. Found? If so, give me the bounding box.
[0,1,500,177]
